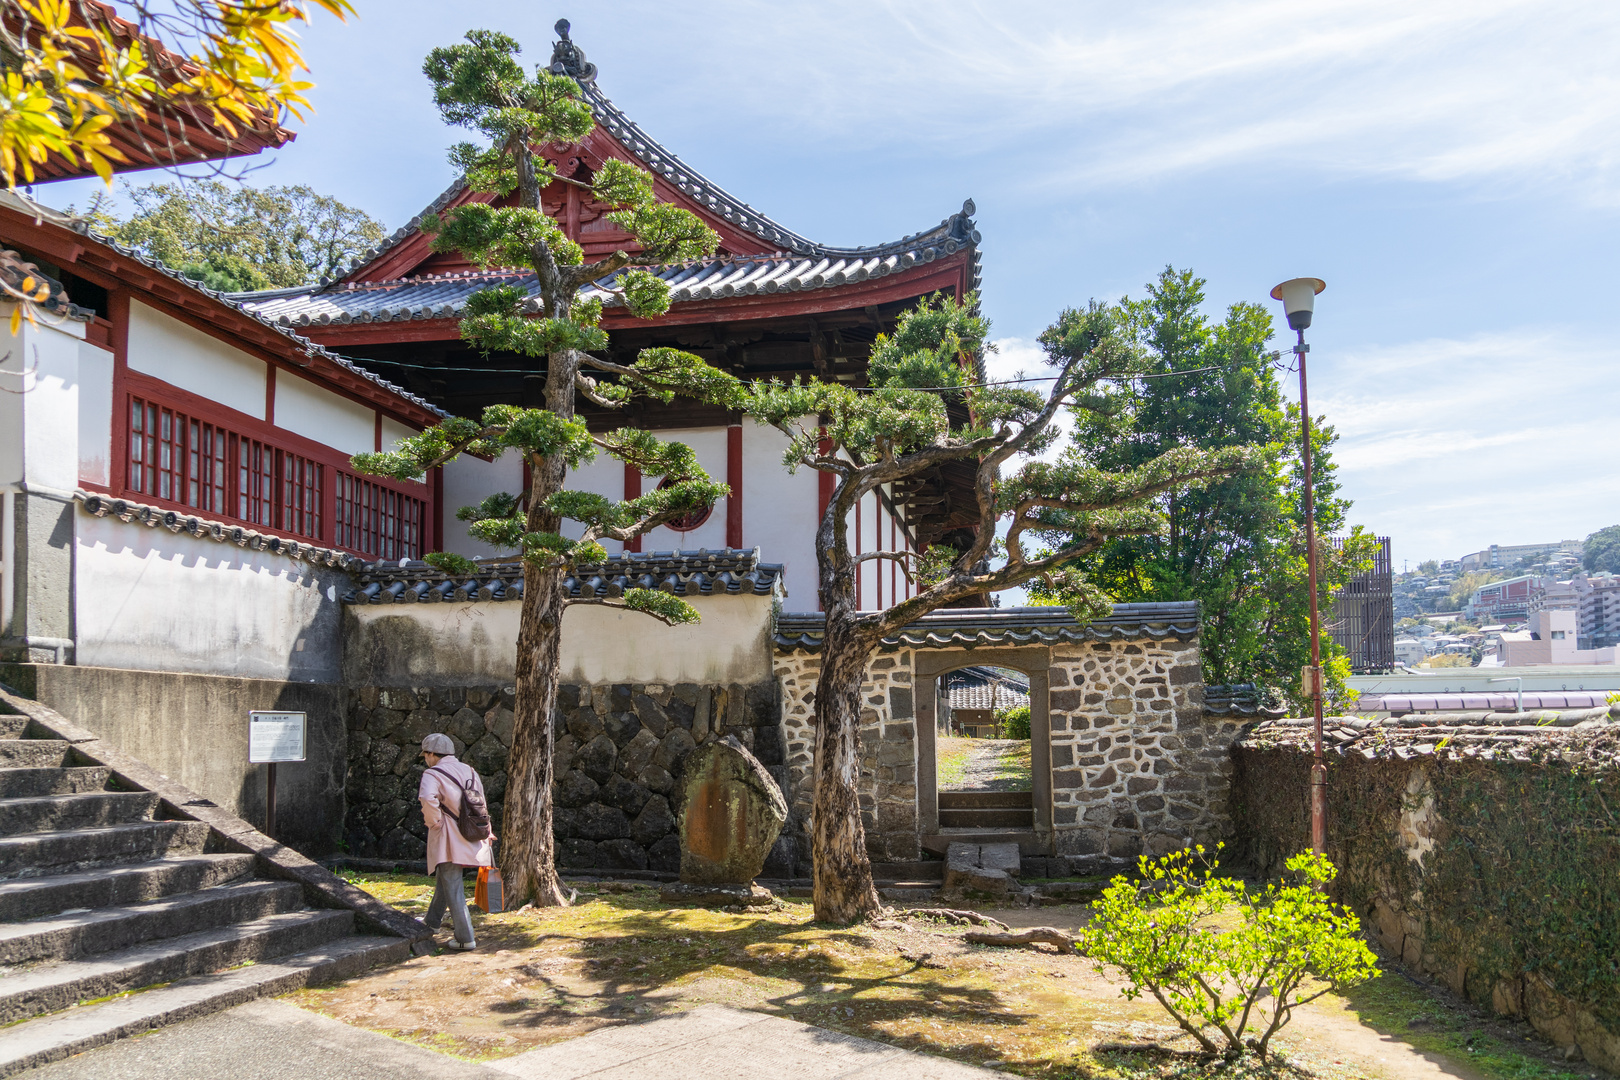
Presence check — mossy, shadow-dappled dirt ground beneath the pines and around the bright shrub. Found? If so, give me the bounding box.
[292,874,1592,1080]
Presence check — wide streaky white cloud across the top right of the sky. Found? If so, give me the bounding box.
[690,0,1620,201]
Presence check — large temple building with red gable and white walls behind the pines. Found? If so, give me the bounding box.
[240,23,978,610]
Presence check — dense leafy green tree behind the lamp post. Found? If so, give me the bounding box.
[1072,267,1372,706]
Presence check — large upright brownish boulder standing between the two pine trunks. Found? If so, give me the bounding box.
[676,735,787,886]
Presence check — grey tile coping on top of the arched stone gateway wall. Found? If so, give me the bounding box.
[773,601,1199,653]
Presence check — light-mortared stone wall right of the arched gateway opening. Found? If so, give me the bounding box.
[1048,640,1241,858]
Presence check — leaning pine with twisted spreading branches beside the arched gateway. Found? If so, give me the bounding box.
[739,296,1252,923]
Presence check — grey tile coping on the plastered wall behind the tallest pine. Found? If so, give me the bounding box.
[343,547,782,604]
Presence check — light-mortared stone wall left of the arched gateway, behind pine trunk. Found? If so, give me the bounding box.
[776,649,922,874]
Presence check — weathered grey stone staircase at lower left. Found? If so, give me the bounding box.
[0,690,424,1077]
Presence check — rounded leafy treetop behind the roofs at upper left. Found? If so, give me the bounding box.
[103,180,386,293]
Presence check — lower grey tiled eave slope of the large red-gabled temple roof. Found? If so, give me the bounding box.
[238,236,969,327]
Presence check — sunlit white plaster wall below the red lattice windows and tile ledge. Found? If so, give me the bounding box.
[73,512,347,682]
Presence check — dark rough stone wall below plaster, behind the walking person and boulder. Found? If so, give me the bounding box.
[345,683,794,876]
